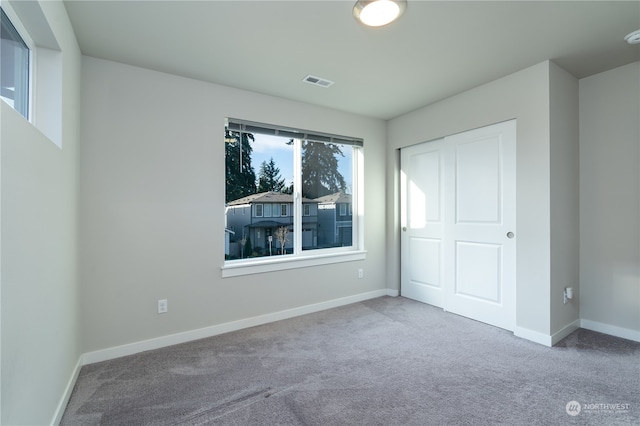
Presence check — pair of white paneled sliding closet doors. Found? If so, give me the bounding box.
[401,121,516,330]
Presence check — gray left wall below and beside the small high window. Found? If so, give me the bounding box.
[0,2,82,425]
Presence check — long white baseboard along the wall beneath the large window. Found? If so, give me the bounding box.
[82,289,392,365]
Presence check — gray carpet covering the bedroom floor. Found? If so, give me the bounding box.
[61,297,640,426]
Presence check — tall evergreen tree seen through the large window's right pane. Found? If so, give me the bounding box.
[302,141,347,198]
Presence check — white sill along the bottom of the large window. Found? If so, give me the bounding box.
[221,250,367,278]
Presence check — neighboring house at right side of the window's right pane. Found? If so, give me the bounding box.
[315,192,353,247]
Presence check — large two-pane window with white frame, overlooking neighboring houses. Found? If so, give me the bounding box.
[223,119,364,276]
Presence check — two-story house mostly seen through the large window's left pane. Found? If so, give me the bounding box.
[225,192,318,257]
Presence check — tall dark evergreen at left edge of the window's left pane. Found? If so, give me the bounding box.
[225,131,256,202]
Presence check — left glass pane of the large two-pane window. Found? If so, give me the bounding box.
[225,131,294,260]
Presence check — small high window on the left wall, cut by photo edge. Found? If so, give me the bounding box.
[0,9,30,119]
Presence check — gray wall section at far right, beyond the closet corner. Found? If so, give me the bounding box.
[580,62,640,339]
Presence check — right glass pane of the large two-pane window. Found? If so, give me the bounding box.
[302,141,353,250]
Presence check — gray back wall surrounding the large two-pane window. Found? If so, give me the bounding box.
[80,57,387,352]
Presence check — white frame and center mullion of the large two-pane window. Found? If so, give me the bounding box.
[221,119,366,278]
